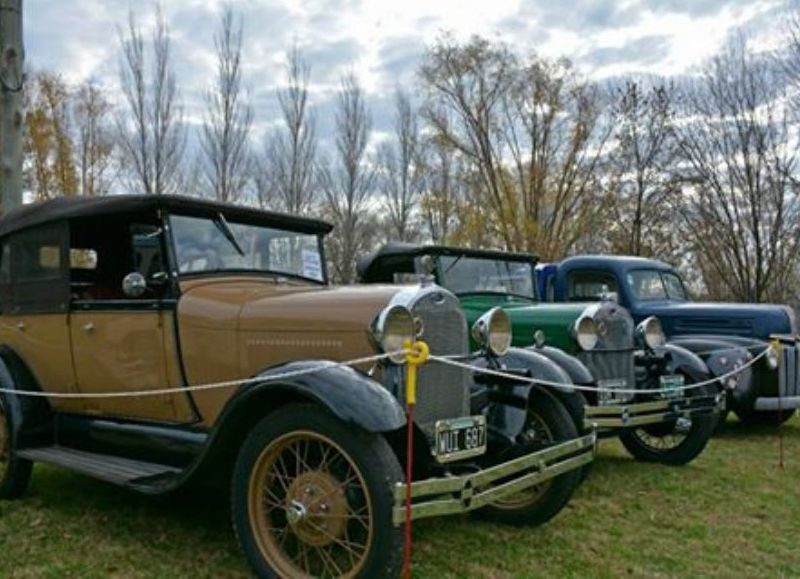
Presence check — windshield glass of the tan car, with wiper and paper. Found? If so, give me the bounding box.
[171,215,325,282]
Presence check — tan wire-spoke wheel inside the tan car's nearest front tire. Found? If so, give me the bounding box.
[248,431,374,577]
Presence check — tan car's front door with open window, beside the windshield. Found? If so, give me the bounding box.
[69,216,195,422]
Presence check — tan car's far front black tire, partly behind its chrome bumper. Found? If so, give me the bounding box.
[475,389,584,526]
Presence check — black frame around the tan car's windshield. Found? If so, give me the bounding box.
[163,211,330,286]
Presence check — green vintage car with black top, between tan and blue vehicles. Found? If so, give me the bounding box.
[358,243,736,464]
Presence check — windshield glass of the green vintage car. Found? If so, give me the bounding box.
[439,255,536,299]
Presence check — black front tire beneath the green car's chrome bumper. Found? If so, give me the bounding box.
[619,380,719,466]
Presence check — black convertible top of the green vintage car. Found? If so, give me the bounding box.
[356,241,538,283]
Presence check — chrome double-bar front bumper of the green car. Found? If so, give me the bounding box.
[584,392,725,428]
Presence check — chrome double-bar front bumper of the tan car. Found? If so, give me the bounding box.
[392,433,597,525]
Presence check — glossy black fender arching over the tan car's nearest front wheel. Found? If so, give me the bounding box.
[242,360,406,432]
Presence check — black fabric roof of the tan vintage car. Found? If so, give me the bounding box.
[0,195,333,235]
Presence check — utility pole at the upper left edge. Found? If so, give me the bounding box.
[0,0,25,213]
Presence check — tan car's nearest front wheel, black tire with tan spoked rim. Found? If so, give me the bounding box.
[231,404,404,578]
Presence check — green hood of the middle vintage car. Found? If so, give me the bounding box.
[460,294,593,352]
